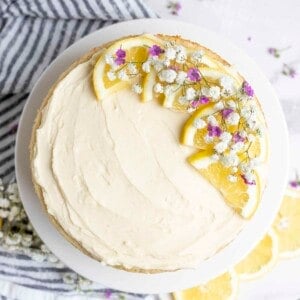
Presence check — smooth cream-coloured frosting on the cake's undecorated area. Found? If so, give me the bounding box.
[33,56,245,270]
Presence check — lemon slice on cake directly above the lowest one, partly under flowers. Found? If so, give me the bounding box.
[180,104,218,149]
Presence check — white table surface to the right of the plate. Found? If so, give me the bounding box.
[145,0,300,300]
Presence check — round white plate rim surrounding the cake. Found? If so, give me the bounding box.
[16,19,288,293]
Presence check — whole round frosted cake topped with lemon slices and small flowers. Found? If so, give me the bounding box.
[30,34,268,273]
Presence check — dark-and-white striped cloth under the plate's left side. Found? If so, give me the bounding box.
[0,0,156,300]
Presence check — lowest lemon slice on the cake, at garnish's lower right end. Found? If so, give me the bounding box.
[188,150,261,219]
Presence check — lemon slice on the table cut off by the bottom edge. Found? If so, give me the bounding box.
[173,271,238,300]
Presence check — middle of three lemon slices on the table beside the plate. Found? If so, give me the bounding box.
[235,230,278,280]
